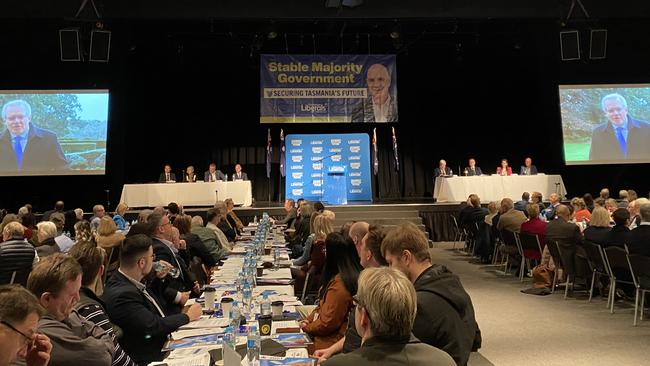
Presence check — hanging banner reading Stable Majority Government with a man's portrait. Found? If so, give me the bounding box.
[260,55,398,123]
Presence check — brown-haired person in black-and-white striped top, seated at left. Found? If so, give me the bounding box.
[68,242,136,366]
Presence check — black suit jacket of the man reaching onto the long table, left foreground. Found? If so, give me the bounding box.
[101,271,189,364]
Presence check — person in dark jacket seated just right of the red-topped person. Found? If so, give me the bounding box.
[546,205,585,284]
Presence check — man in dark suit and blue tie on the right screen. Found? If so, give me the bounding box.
[589,93,650,161]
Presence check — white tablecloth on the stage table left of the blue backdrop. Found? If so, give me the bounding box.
[120,180,253,207]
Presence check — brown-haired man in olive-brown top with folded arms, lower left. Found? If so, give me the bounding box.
[27,253,115,366]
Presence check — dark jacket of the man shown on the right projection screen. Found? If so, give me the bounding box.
[589,115,650,160]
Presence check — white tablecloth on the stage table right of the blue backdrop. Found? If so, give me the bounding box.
[433,174,566,202]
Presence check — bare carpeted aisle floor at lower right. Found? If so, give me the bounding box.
[431,243,650,366]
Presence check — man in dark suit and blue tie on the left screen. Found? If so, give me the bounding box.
[0,99,69,174]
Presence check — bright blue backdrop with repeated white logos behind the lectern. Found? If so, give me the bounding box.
[286,133,372,202]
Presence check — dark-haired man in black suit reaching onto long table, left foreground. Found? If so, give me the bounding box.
[102,234,202,365]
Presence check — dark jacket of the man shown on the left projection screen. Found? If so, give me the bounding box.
[0,124,69,174]
